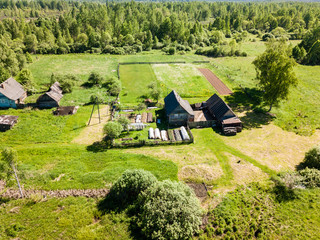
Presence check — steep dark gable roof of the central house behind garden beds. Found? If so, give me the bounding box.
[164,90,194,115]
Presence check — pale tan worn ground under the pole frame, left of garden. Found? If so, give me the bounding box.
[72,106,110,145]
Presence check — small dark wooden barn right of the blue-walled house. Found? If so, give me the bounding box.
[37,82,63,108]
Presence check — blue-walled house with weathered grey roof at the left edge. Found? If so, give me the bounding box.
[0,77,27,108]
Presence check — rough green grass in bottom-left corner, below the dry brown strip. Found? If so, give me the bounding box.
[0,197,131,239]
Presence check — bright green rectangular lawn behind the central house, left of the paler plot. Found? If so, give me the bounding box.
[120,64,157,104]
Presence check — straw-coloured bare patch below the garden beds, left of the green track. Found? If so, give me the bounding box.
[127,145,223,184]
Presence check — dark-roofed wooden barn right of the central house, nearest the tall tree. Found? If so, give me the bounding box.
[205,94,242,132]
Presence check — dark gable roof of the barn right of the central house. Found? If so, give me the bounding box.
[207,94,236,121]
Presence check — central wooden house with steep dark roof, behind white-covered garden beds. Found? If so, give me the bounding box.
[164,90,194,126]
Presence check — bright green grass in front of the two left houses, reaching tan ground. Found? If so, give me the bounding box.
[0,106,92,145]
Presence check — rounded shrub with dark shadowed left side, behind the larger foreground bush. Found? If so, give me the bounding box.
[109,169,157,205]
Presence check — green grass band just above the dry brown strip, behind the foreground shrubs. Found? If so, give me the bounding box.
[16,144,178,190]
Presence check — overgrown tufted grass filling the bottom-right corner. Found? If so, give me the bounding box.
[199,184,320,239]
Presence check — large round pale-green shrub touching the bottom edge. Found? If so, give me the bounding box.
[138,180,202,239]
